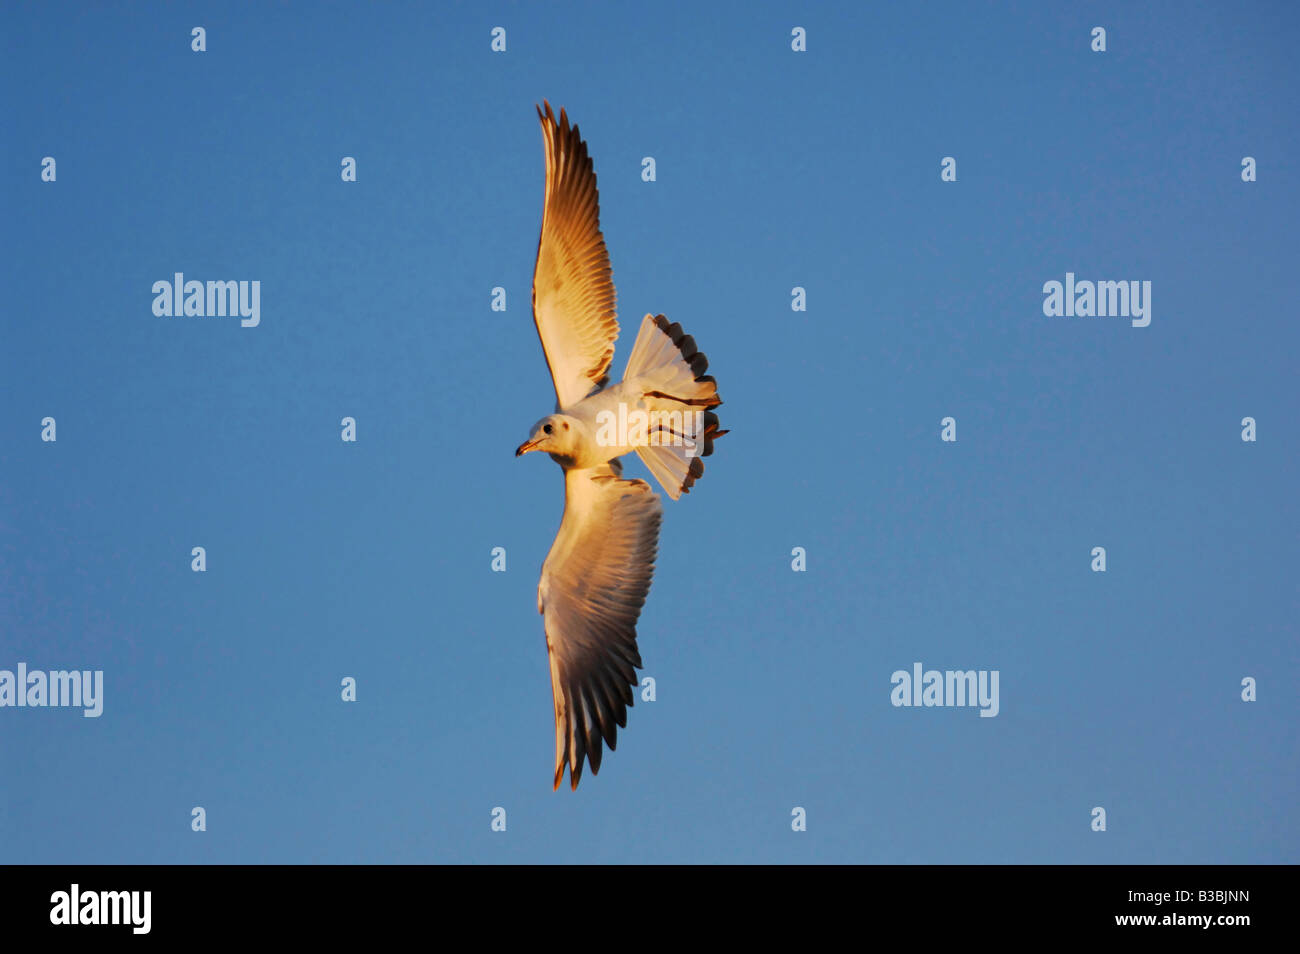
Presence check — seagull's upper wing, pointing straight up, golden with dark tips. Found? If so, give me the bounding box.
[533,103,619,409]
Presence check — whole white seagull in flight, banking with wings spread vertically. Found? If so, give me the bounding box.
[515,100,727,789]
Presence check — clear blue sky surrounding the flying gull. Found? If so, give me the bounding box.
[0,1,1300,863]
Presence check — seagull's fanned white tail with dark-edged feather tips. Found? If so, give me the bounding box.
[623,315,727,500]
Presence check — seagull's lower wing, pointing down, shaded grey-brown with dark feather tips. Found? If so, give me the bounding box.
[537,465,662,789]
